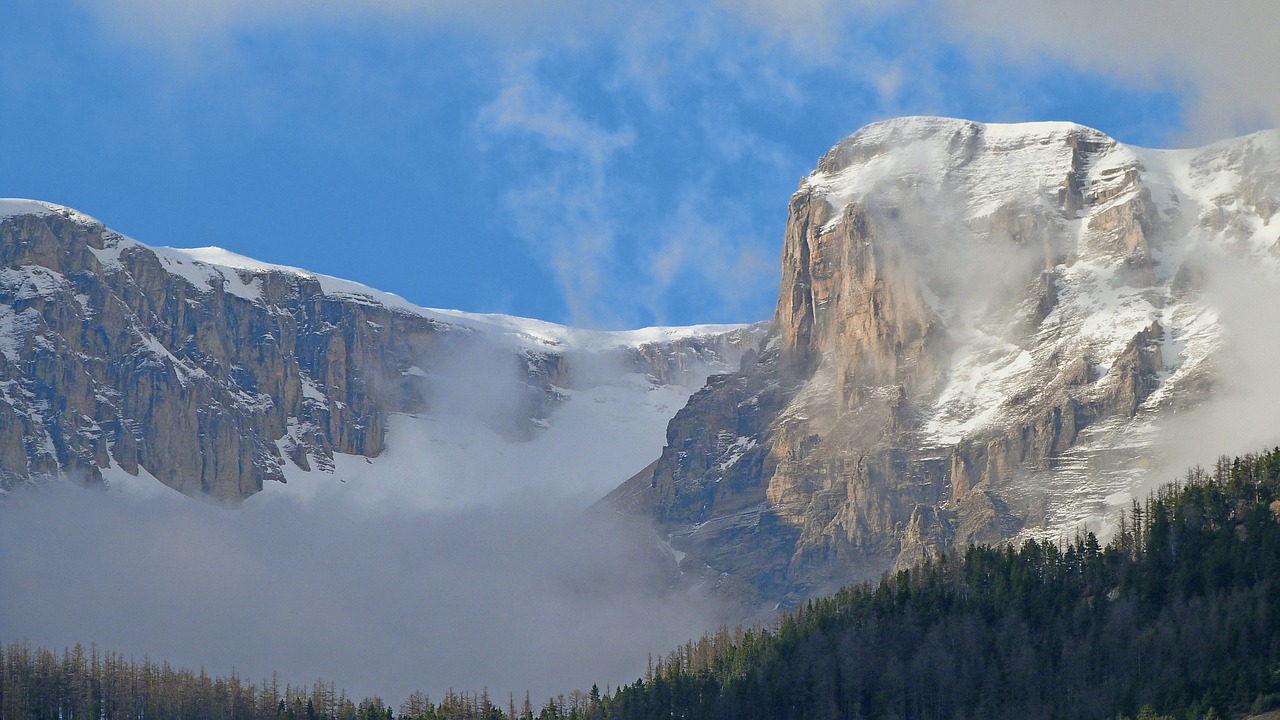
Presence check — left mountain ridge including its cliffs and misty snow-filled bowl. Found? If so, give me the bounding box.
[0,200,763,506]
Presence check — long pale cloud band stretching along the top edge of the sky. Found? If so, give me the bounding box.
[79,0,1280,140]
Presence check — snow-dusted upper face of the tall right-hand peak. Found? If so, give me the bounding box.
[801,118,1280,534]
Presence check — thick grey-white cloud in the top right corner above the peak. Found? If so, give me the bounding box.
[940,0,1280,143]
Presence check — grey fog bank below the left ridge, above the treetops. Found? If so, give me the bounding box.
[0,487,716,703]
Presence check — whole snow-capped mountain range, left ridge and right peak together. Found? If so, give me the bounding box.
[10,118,1280,606]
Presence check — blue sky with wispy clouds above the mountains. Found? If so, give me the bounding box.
[0,0,1280,328]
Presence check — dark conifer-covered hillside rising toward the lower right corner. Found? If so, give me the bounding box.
[605,448,1280,720]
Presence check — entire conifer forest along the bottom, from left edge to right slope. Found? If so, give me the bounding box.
[0,448,1280,720]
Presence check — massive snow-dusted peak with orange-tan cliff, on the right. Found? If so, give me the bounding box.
[607,118,1280,605]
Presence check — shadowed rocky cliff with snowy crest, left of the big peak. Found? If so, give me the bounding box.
[0,201,759,503]
